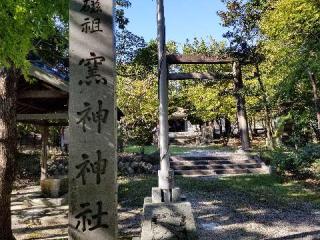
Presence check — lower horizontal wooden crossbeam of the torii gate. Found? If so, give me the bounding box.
[168,73,233,80]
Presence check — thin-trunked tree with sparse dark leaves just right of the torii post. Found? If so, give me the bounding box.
[218,0,273,147]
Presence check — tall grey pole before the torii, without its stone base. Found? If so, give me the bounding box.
[157,0,173,202]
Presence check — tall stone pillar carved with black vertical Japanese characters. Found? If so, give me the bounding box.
[69,0,117,240]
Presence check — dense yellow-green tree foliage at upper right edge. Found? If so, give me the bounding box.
[260,0,320,144]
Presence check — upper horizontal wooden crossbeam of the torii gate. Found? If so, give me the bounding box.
[167,55,236,64]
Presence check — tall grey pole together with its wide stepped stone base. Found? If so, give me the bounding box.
[141,0,197,240]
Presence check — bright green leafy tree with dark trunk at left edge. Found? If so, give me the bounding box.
[0,0,68,240]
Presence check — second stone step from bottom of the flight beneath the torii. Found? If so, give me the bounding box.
[171,163,261,170]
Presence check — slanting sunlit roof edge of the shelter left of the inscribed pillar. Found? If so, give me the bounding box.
[30,65,69,92]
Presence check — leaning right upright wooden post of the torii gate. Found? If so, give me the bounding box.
[233,62,250,150]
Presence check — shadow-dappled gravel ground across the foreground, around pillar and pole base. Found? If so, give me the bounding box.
[12,182,320,240]
